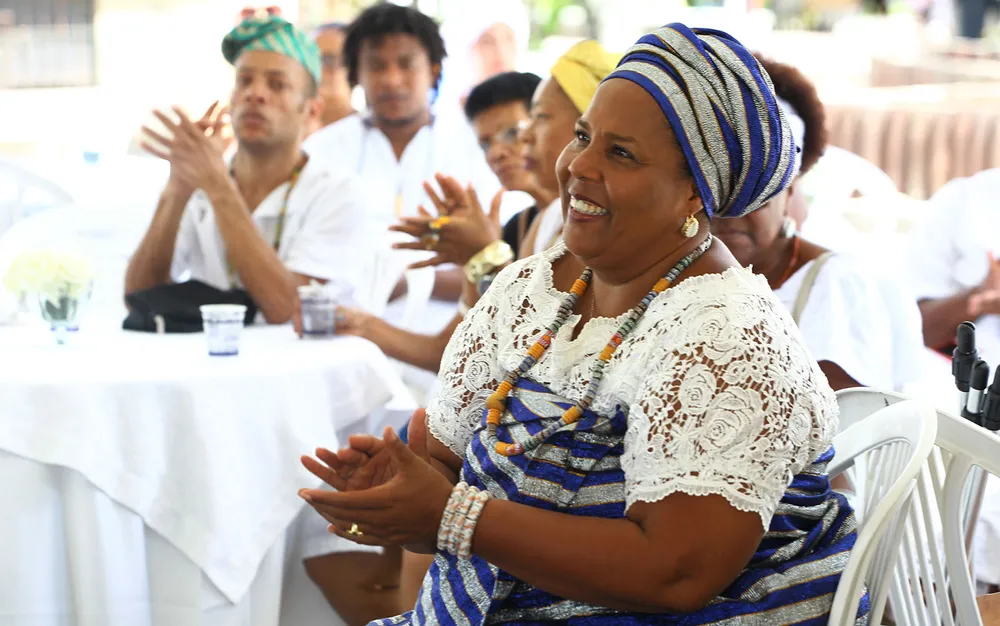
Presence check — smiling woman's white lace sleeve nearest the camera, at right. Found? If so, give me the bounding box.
[622,294,837,531]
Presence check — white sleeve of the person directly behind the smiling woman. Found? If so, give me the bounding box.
[799,256,900,389]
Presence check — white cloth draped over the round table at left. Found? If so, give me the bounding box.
[0,327,405,623]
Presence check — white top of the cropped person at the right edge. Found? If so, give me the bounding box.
[907,169,1000,364]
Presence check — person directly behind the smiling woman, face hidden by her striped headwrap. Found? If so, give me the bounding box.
[712,58,922,390]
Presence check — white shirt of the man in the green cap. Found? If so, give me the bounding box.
[171,159,373,298]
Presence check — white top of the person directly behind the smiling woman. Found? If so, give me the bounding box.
[774,255,924,389]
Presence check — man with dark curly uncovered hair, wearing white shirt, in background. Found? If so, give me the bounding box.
[304,3,526,334]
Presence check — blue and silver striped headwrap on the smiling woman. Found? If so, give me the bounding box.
[606,24,797,217]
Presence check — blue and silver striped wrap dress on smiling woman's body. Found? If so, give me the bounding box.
[373,378,868,626]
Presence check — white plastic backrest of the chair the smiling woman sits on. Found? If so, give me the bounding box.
[829,400,937,625]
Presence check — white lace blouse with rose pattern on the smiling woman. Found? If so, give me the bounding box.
[427,242,837,530]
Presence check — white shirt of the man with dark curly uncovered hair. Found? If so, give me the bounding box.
[303,115,530,225]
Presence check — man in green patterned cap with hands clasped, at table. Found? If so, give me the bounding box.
[125,15,371,324]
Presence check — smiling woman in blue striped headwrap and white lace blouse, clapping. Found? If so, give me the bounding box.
[301,24,867,625]
